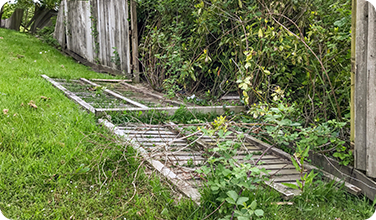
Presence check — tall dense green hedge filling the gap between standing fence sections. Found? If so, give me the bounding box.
[139,0,351,122]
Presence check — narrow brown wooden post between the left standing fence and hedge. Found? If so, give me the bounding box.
[130,0,140,83]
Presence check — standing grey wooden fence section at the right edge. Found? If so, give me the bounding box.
[354,0,376,178]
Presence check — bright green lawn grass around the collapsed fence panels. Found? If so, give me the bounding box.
[0,29,375,219]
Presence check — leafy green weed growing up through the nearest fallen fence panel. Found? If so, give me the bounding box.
[197,117,267,220]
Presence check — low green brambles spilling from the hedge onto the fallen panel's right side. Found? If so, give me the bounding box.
[249,101,353,165]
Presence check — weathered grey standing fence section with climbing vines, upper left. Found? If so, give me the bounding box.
[54,0,131,75]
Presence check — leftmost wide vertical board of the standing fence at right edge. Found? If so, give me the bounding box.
[354,0,368,170]
